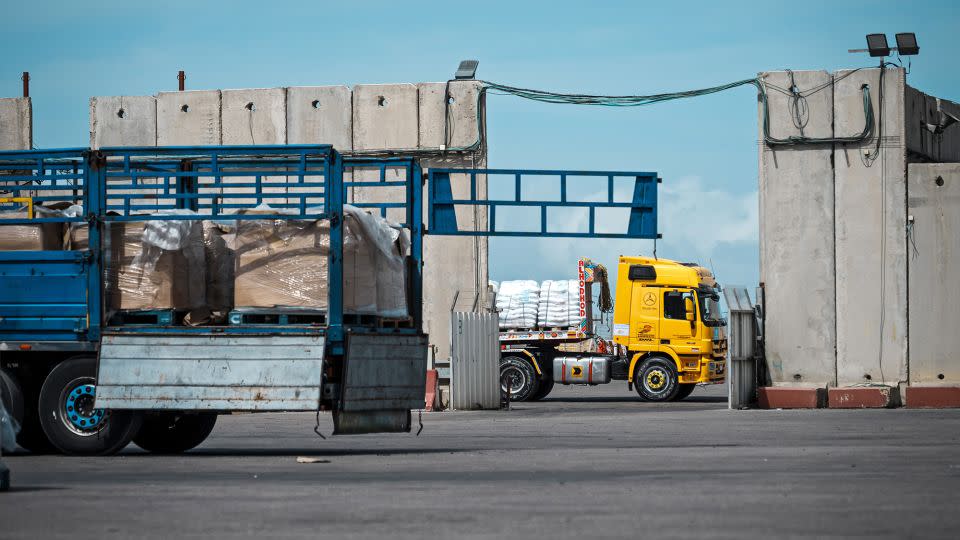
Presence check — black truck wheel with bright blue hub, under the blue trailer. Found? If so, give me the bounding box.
[39,357,143,455]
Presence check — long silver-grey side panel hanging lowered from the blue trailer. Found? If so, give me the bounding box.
[95,335,324,411]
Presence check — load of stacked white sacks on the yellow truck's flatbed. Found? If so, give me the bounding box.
[493,279,580,328]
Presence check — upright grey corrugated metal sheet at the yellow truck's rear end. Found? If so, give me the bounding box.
[450,312,500,410]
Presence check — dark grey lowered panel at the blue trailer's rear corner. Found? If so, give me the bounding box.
[342,334,427,412]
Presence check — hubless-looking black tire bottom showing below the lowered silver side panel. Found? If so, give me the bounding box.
[133,412,217,454]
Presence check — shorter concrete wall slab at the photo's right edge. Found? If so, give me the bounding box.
[907,163,960,385]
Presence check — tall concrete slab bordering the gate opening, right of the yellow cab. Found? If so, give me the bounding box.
[759,71,836,386]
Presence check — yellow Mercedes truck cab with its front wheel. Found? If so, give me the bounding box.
[613,256,726,400]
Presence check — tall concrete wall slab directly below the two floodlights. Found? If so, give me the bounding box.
[834,69,908,386]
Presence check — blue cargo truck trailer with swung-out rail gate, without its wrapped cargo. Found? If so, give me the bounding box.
[0,145,659,455]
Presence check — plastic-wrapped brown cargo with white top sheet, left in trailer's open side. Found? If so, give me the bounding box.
[105,210,207,310]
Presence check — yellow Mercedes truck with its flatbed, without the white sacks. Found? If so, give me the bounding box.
[500,256,726,401]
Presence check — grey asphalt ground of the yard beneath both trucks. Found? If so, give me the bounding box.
[0,384,960,540]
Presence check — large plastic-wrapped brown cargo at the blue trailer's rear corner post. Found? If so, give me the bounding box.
[234,205,409,317]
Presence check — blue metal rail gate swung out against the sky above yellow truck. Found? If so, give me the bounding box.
[428,169,660,239]
